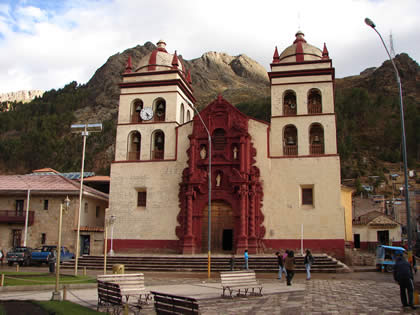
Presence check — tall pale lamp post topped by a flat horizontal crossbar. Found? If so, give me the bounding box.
[71,124,102,276]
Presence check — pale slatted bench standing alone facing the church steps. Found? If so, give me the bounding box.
[220,270,262,297]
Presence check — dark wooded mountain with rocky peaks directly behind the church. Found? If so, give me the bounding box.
[0,42,420,178]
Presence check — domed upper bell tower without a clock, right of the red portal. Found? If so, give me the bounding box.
[269,31,337,158]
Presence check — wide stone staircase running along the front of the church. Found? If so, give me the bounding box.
[61,254,348,273]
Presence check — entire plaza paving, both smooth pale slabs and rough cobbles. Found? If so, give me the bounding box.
[0,272,420,315]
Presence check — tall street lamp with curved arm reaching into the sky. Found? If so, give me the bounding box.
[365,18,412,263]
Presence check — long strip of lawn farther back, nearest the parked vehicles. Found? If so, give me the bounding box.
[3,272,96,286]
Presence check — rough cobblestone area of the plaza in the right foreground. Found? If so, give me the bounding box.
[141,279,420,315]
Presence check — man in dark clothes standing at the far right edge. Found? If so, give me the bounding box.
[394,251,416,309]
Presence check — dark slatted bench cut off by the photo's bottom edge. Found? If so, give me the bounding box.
[151,291,200,315]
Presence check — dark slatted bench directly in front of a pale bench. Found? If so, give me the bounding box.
[97,280,141,314]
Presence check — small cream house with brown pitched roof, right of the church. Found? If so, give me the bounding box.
[353,211,401,250]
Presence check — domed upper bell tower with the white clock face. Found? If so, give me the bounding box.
[115,40,195,161]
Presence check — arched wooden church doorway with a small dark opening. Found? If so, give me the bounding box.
[201,200,235,252]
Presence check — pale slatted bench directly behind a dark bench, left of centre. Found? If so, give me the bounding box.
[97,273,151,303]
